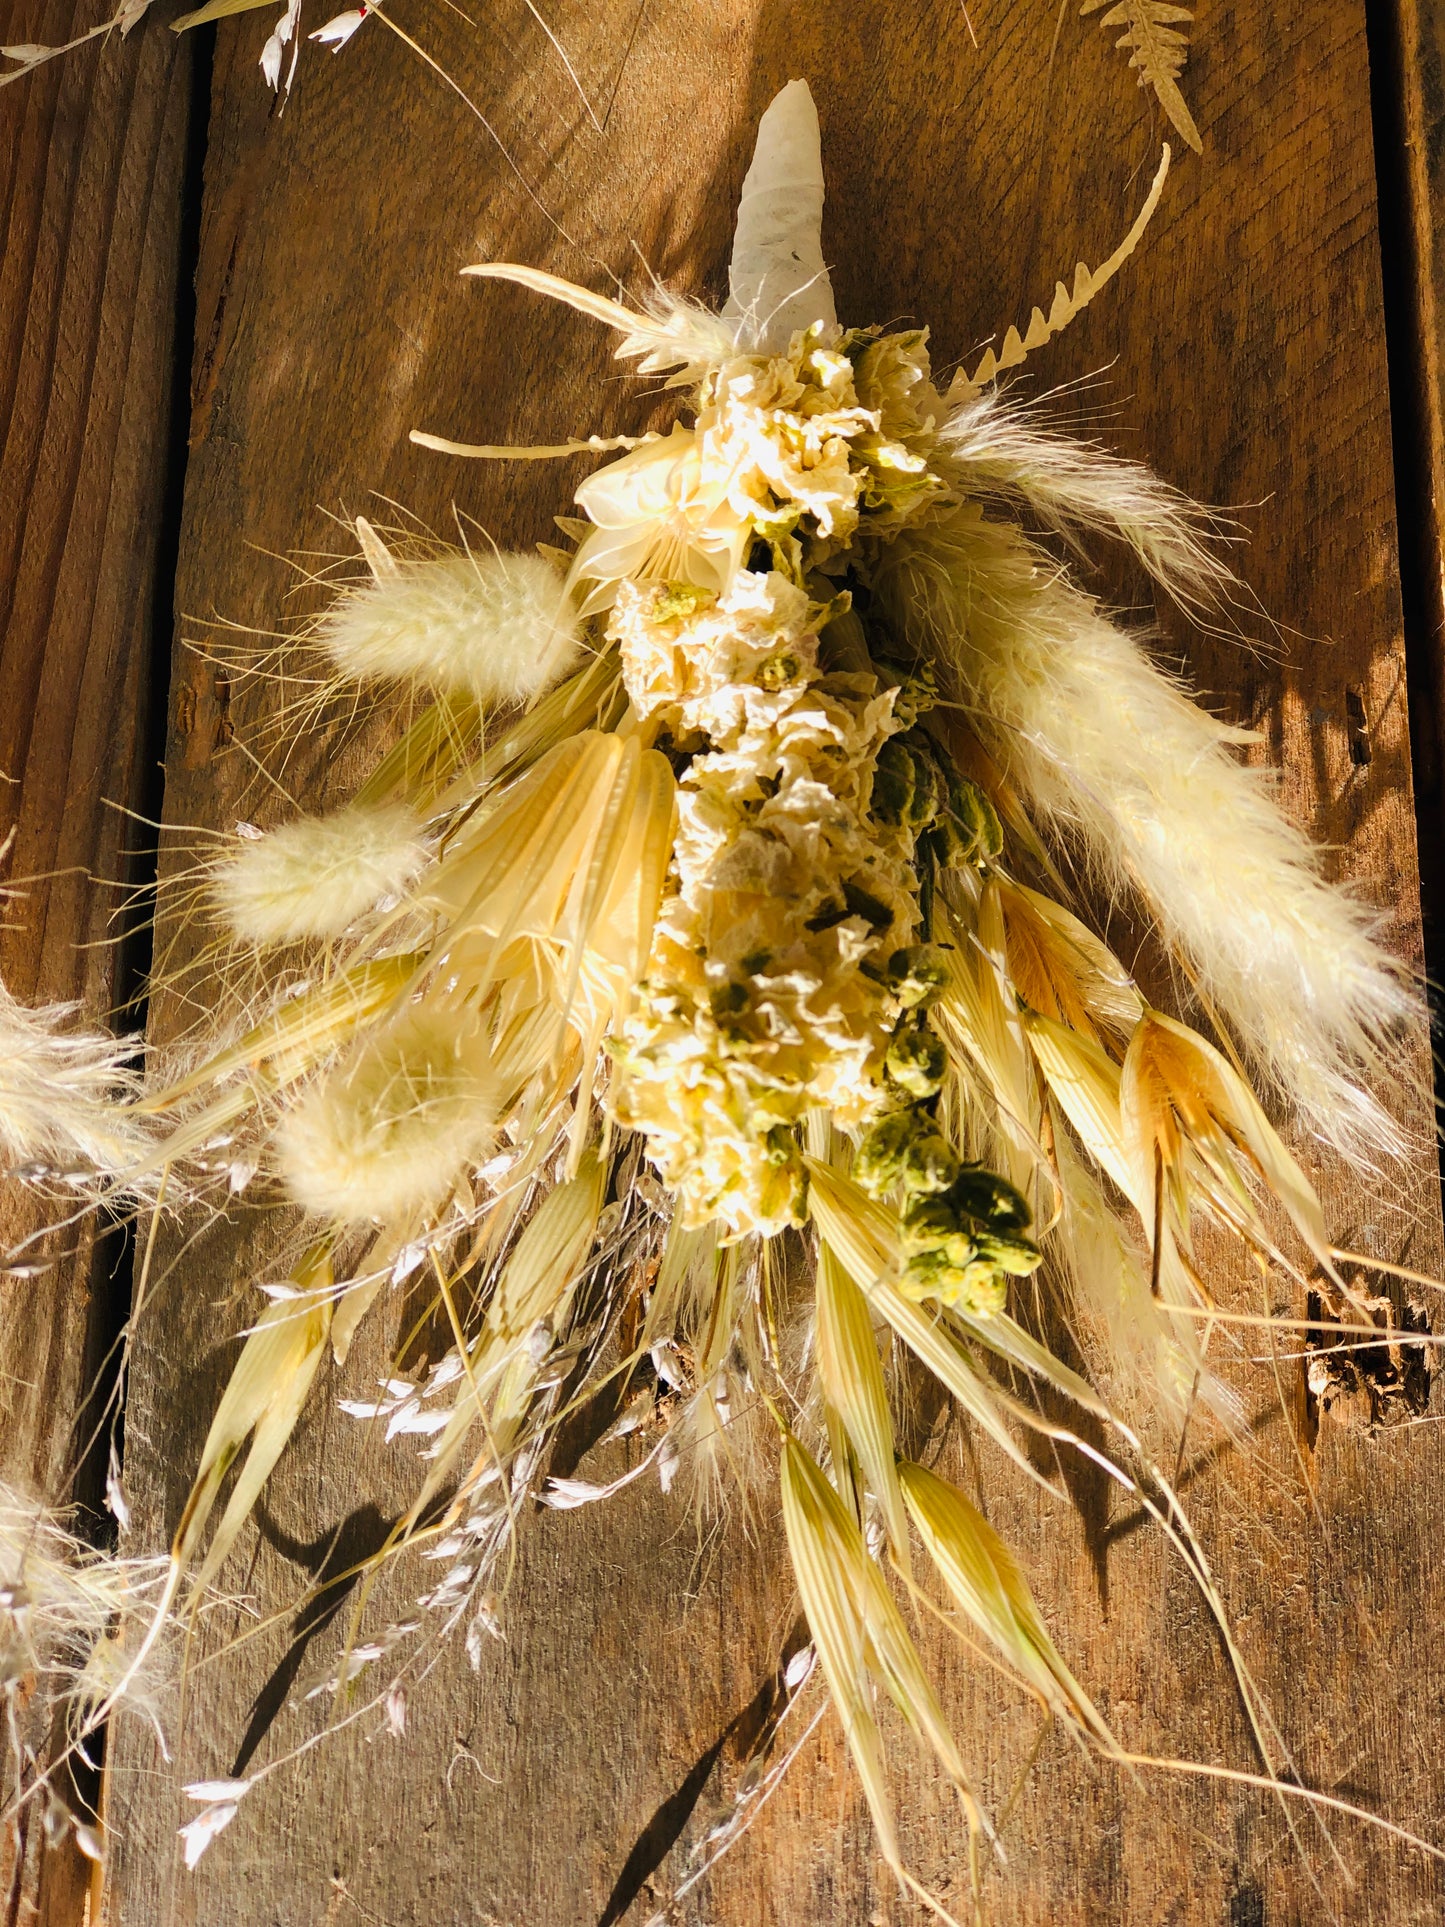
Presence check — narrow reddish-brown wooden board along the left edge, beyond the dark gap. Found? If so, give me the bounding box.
[0,0,191,1923]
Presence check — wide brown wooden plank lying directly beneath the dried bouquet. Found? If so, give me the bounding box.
[114,0,1445,1927]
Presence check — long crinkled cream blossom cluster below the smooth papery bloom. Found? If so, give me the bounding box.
[613,570,917,1233]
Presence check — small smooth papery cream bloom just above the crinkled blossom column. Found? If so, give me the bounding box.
[568,426,749,617]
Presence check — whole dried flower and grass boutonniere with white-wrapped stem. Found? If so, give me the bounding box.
[0,81,1441,1911]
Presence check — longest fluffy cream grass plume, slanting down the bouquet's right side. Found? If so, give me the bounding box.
[882,509,1414,1152]
